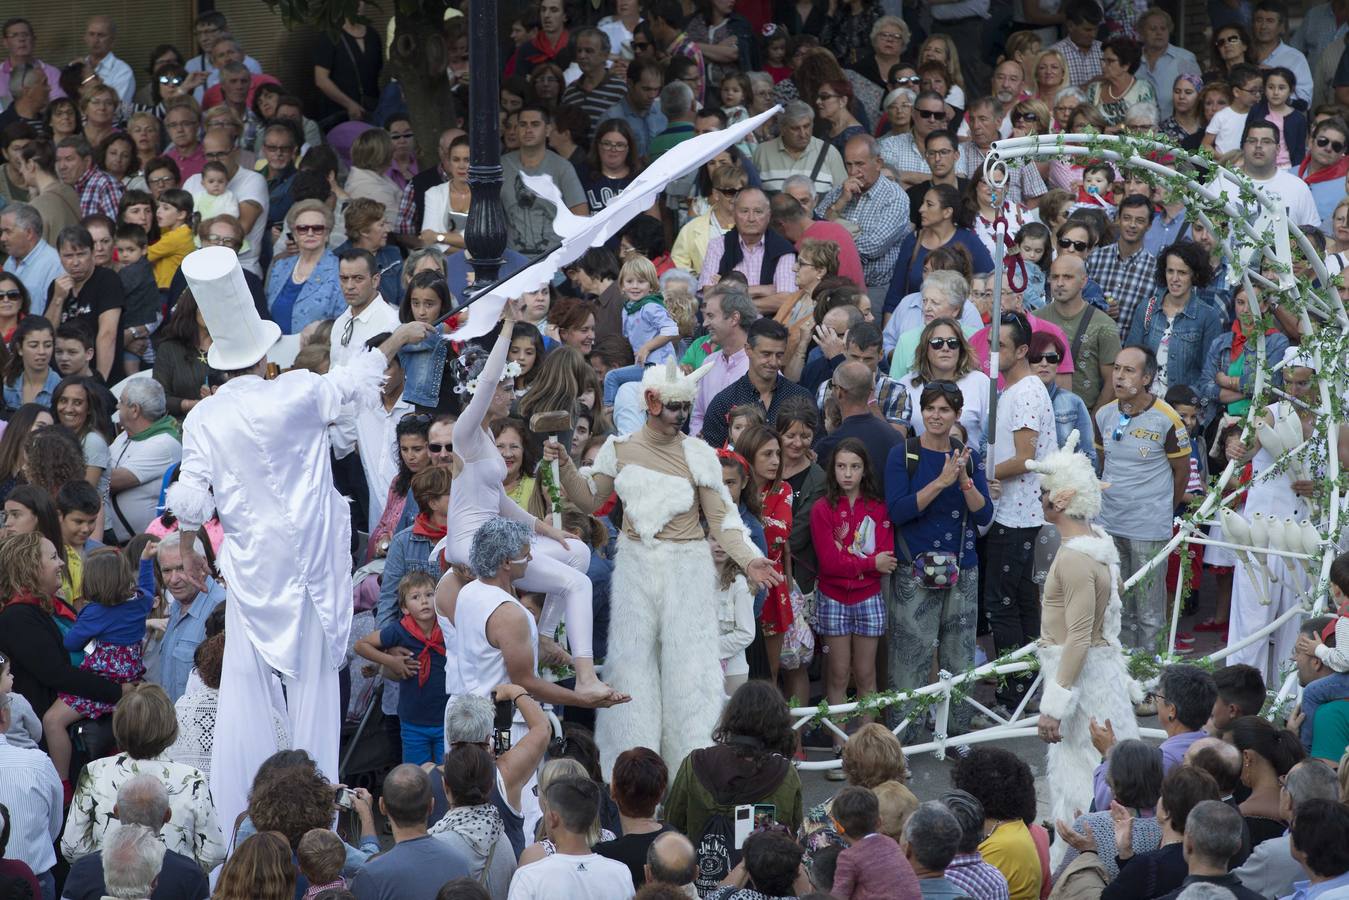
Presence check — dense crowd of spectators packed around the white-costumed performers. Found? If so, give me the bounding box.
[0,0,1349,900]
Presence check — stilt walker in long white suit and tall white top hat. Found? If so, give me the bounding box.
[167,247,429,820]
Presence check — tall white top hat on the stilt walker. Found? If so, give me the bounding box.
[182,247,281,372]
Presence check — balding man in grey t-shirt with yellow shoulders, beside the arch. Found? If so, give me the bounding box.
[1093,345,1190,652]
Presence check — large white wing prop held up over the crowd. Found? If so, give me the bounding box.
[447,107,781,340]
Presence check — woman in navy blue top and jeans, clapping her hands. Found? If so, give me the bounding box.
[885,377,993,734]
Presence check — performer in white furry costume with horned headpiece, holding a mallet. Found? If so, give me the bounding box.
[544,362,780,773]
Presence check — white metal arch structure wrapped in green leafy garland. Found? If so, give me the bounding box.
[792,134,1349,769]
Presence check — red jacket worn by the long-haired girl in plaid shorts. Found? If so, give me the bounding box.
[811,497,894,604]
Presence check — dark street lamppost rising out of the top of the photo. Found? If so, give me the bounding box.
[464,0,506,293]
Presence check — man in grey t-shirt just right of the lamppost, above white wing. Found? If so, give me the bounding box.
[502,105,590,256]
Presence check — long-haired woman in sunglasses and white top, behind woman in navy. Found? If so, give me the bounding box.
[900,316,989,447]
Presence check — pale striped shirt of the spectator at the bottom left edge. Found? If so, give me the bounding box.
[0,734,62,874]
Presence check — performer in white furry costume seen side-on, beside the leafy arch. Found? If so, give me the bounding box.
[1027,432,1143,858]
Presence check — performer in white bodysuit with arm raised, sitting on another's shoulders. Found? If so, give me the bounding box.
[441,310,610,700]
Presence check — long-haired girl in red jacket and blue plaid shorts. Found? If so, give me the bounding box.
[811,437,897,753]
